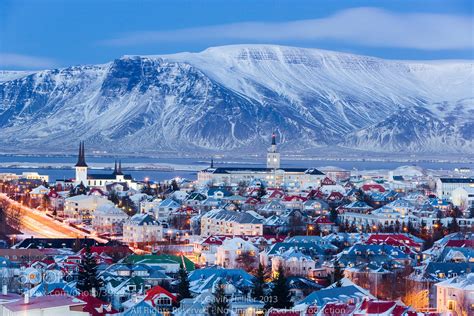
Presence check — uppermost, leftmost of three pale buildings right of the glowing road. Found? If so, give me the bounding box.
[64,195,113,220]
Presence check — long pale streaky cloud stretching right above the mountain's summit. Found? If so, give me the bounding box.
[102,7,474,50]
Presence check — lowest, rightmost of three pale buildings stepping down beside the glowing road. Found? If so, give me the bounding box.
[123,214,163,244]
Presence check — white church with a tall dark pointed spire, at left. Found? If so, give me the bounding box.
[74,142,134,188]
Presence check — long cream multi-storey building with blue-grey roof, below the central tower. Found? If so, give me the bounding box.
[201,209,263,236]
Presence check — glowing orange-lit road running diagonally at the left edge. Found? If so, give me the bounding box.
[0,193,105,242]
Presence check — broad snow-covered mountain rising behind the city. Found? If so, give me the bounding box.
[0,45,474,153]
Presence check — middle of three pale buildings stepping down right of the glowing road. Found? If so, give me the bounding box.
[92,204,128,235]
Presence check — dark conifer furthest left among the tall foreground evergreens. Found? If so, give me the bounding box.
[77,244,102,296]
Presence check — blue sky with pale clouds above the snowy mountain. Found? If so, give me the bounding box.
[0,0,474,69]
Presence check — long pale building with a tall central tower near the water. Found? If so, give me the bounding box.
[198,133,324,188]
